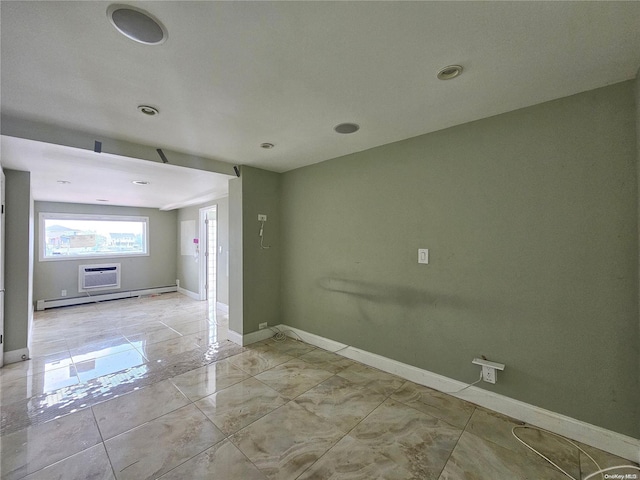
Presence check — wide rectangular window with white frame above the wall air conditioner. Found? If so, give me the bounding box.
[39,213,149,261]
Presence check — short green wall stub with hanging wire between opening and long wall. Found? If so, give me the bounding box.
[229,166,282,335]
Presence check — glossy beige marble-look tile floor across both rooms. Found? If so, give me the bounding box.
[0,294,640,480]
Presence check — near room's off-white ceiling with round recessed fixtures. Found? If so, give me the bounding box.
[0,1,640,207]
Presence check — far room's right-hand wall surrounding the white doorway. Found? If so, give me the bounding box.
[177,197,229,305]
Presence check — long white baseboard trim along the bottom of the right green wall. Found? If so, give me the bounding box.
[276,325,640,462]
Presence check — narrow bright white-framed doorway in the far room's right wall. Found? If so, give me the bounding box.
[200,205,218,321]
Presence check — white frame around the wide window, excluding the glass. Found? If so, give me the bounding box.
[38,212,149,262]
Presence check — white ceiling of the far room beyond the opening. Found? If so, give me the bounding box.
[2,135,231,210]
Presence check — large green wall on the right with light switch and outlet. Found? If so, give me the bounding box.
[280,82,640,438]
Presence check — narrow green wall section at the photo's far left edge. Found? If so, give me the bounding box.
[4,169,33,354]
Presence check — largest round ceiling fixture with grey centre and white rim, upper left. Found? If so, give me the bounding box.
[107,4,167,45]
